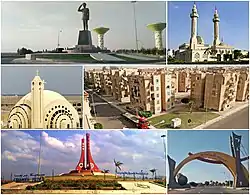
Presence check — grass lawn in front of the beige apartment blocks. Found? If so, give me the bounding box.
[149,111,219,129]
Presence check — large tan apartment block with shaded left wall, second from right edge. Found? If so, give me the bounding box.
[204,72,239,111]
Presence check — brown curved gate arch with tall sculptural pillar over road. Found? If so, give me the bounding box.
[168,133,249,188]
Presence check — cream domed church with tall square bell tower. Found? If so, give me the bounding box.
[7,73,80,129]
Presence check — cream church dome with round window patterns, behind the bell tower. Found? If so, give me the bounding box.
[8,90,80,129]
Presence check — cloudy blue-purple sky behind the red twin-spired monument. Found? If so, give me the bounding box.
[1,130,166,179]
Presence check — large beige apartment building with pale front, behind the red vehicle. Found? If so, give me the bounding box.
[128,71,174,114]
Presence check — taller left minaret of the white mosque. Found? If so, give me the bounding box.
[190,4,199,49]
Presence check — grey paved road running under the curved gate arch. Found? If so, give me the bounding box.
[168,187,249,194]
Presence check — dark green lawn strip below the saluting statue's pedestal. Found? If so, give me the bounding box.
[41,53,95,62]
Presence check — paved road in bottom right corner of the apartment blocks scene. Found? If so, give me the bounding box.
[205,107,249,129]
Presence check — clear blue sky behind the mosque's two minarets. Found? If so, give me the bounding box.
[168,1,249,50]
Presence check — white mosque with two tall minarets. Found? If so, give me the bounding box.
[175,4,234,62]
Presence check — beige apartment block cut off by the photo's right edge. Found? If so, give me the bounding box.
[236,71,249,101]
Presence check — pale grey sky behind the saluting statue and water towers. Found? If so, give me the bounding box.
[1,1,166,52]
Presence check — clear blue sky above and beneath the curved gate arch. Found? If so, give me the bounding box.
[167,130,249,182]
